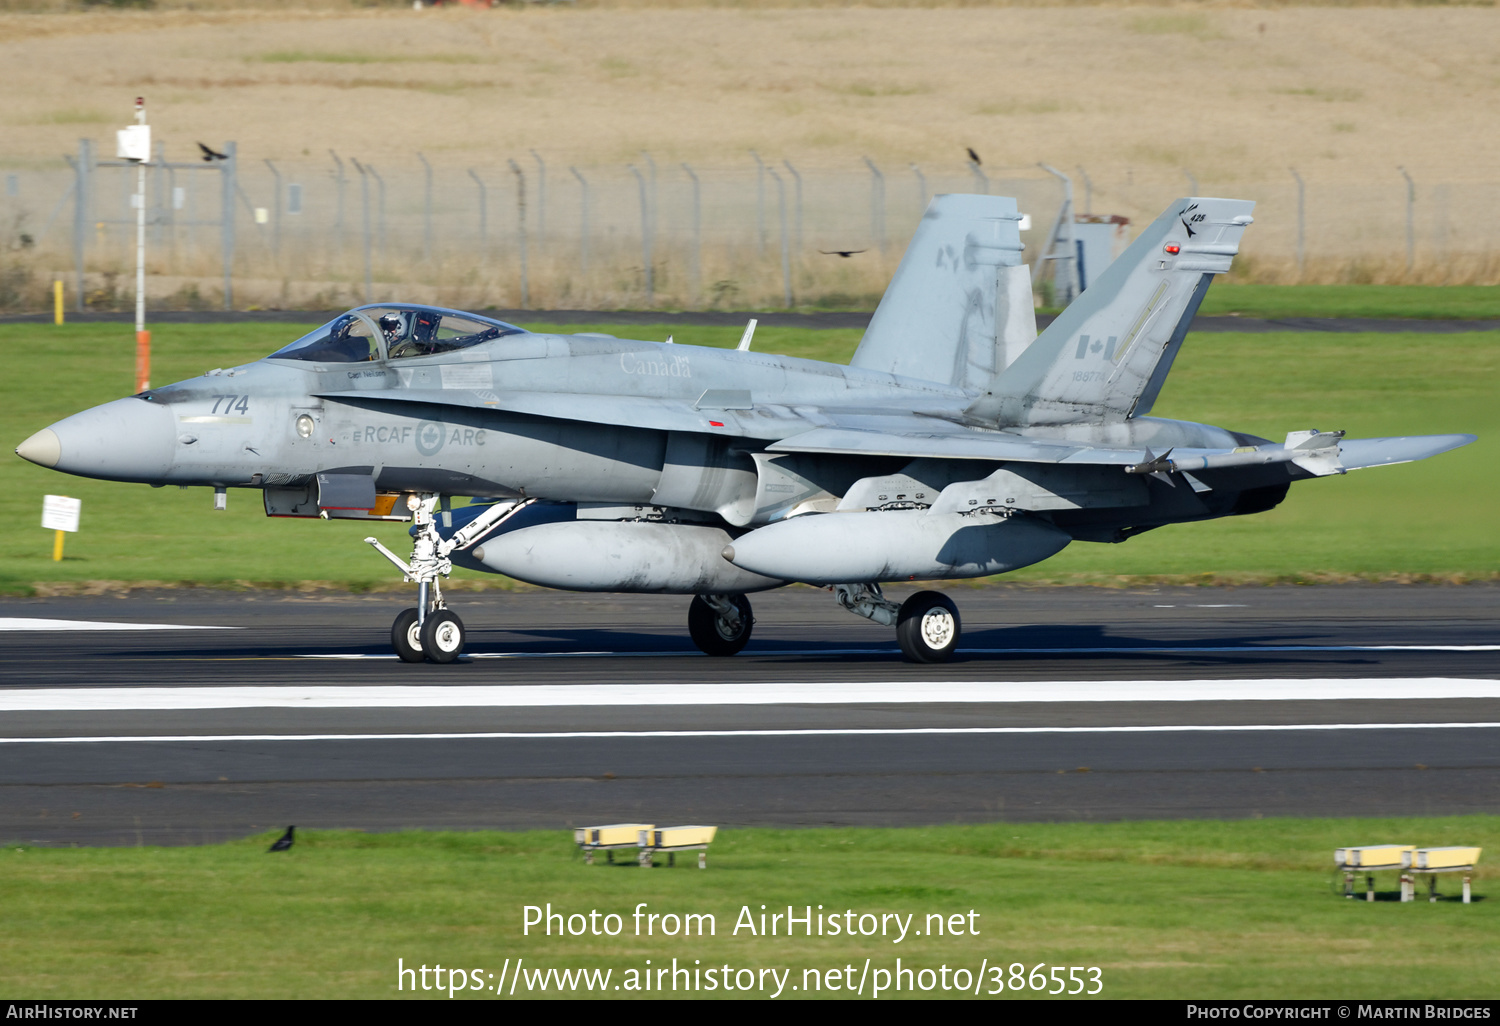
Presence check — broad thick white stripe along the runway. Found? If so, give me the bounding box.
[0,677,1500,713]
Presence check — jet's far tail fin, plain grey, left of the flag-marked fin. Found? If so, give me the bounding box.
[851,195,1037,389]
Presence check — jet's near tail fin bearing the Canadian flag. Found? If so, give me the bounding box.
[969,198,1256,426]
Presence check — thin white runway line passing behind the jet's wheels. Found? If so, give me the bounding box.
[294,645,1500,660]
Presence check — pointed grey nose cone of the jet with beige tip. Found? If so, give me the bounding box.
[15,399,174,482]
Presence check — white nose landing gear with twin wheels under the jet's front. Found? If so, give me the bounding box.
[365,494,530,663]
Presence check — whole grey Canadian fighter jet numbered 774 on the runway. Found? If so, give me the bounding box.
[17,195,1473,663]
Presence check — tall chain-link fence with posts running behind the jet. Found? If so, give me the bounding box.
[0,143,1500,309]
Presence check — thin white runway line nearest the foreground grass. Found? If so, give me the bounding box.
[0,723,1500,744]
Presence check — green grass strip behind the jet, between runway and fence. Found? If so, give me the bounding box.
[0,324,1500,593]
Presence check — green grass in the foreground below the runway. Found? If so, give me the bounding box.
[0,816,1500,999]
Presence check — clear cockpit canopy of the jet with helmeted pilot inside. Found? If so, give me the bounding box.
[267,305,525,363]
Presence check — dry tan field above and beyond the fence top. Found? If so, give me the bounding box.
[0,5,1500,185]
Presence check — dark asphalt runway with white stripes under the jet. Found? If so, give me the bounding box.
[0,585,1500,845]
